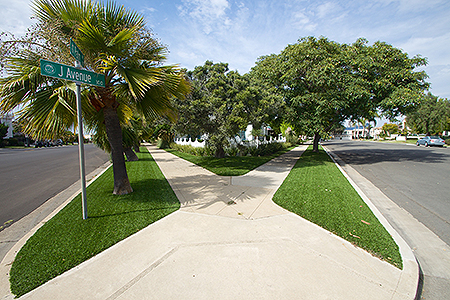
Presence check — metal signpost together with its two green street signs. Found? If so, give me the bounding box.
[40,39,105,220]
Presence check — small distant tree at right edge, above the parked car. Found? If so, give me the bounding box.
[406,93,450,135]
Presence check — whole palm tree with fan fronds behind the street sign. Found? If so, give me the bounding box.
[0,0,189,194]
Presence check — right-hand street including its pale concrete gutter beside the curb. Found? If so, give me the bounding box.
[324,140,450,300]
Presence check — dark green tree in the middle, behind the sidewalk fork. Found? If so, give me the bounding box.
[175,61,281,158]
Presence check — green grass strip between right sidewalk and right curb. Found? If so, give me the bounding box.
[273,146,403,269]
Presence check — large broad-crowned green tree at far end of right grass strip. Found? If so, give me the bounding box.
[252,37,428,151]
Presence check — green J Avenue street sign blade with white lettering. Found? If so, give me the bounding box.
[41,59,105,87]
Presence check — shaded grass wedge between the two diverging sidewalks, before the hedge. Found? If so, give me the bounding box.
[166,146,296,176]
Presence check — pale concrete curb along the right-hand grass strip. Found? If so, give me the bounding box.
[322,145,420,299]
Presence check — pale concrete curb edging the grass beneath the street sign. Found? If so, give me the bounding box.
[0,161,112,300]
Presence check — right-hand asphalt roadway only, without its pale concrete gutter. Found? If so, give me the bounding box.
[325,141,450,245]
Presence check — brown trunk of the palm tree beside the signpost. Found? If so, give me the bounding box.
[103,107,133,195]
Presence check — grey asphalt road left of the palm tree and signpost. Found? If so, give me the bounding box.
[0,144,109,227]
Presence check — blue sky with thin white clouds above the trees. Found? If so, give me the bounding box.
[0,0,450,99]
